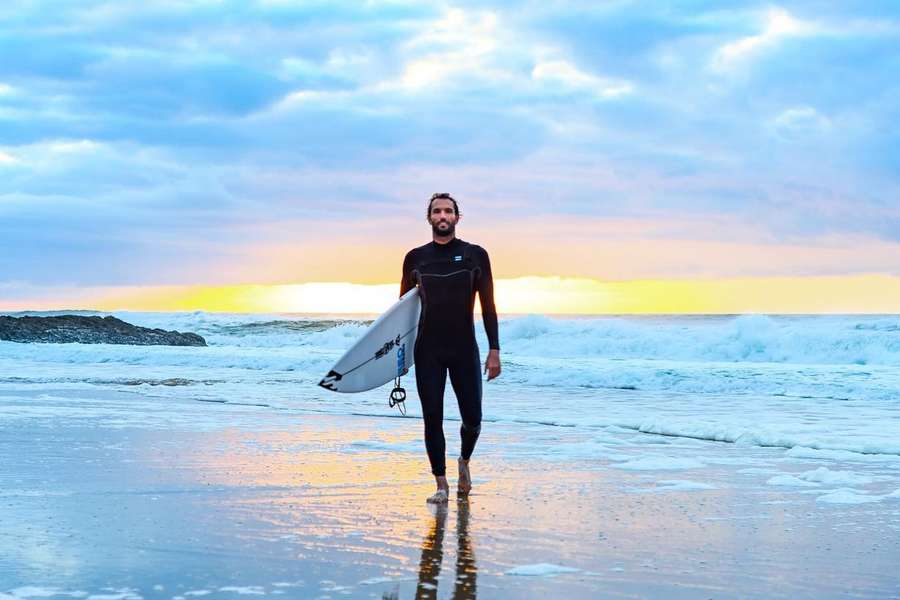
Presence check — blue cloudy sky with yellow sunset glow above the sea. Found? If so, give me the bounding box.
[0,0,900,312]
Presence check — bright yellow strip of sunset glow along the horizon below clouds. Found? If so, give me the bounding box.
[7,275,900,314]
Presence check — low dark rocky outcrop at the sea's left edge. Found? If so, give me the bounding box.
[0,315,206,346]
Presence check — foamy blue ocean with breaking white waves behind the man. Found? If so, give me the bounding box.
[0,312,900,458]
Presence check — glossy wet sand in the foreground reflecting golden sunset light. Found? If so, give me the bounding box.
[0,389,900,600]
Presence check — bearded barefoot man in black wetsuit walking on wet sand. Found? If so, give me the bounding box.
[400,194,500,504]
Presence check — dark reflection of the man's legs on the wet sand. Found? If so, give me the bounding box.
[416,499,478,600]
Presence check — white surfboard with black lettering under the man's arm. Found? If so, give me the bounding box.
[319,288,422,393]
